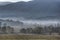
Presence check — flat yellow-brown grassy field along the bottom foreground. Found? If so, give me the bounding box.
[0,34,60,40]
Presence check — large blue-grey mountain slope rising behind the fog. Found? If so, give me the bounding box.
[0,0,60,19]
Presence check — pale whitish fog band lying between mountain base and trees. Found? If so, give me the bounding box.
[0,17,60,25]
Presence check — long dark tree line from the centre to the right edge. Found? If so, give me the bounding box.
[20,25,60,35]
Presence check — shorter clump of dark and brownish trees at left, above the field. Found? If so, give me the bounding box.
[0,23,14,34]
